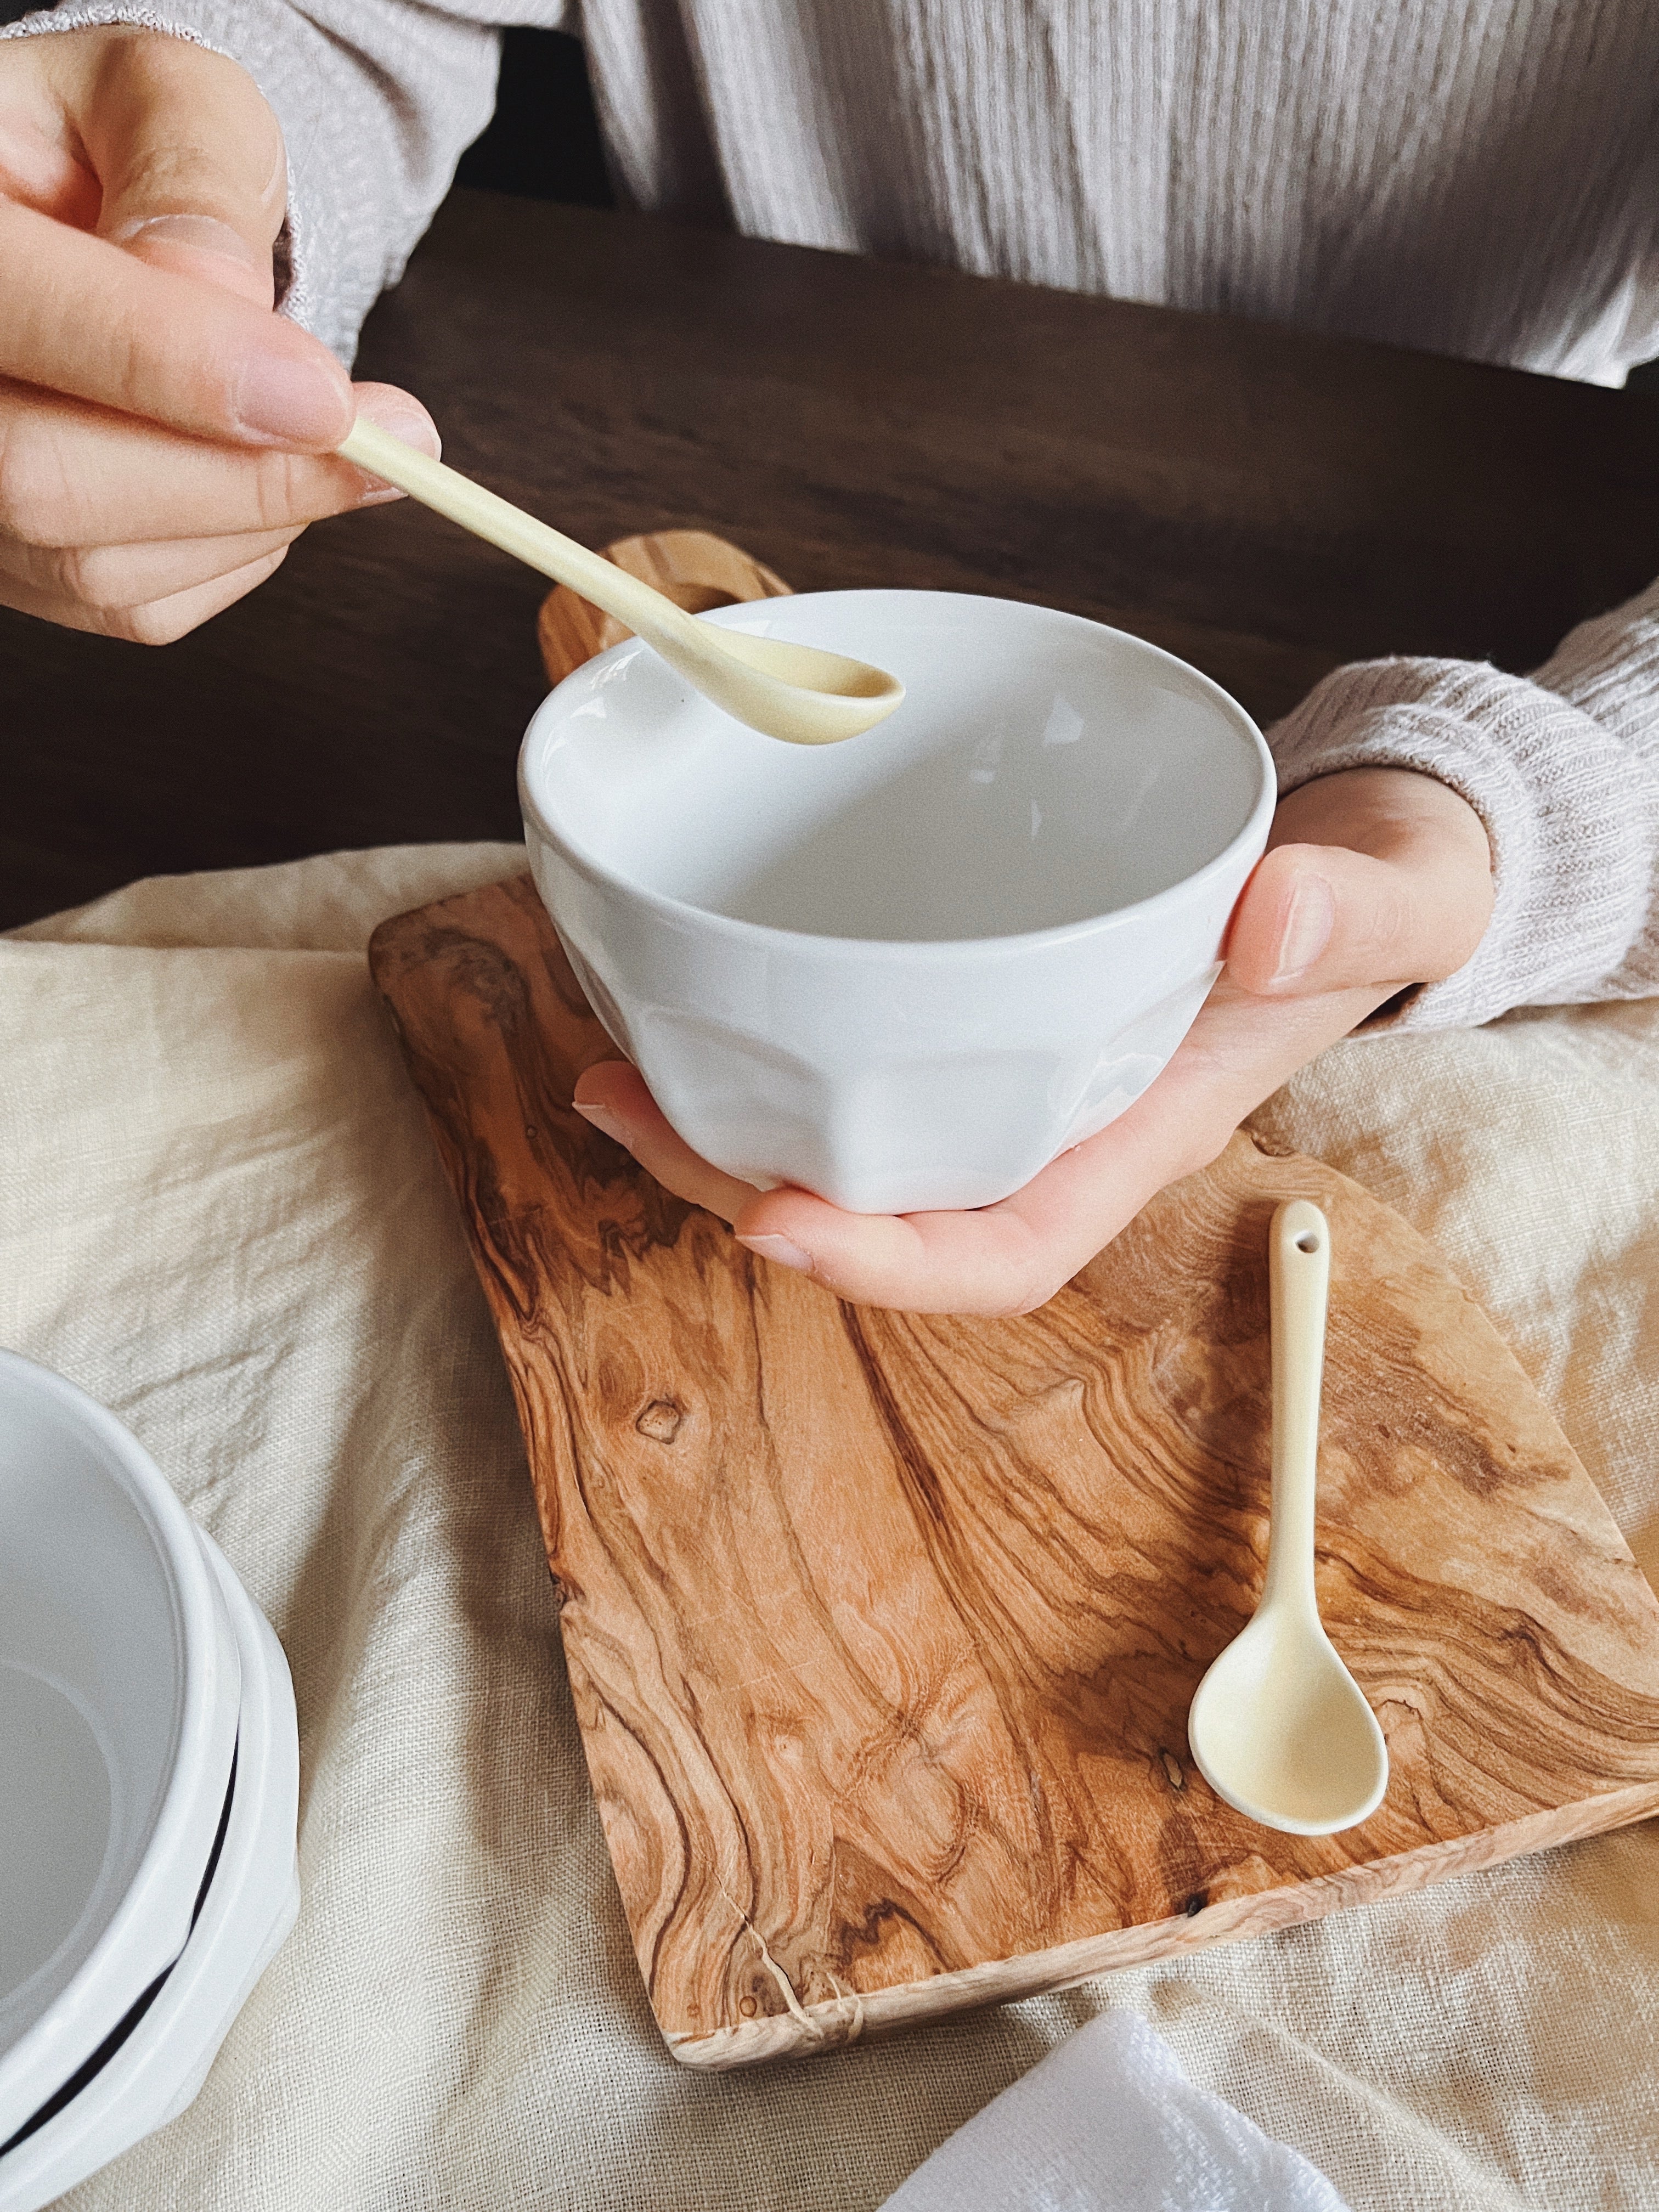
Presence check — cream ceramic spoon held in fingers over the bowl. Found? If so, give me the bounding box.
[341,420,905,746]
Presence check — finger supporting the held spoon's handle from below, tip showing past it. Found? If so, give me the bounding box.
[0,383,440,546]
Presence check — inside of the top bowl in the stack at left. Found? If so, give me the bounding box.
[0,1367,184,2055]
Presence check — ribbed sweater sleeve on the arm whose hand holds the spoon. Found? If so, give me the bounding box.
[0,0,568,365]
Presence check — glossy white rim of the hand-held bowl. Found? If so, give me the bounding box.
[517,586,1278,964]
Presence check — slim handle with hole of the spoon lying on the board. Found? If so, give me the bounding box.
[1263,1199,1331,1619]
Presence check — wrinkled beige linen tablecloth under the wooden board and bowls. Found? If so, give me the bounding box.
[0,845,1659,2212]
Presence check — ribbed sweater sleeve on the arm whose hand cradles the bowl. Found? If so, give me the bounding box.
[1267,584,1659,1029]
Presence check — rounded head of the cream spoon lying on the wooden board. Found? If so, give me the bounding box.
[1186,1608,1389,1836]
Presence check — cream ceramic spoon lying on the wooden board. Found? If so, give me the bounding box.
[1186,1199,1389,1836]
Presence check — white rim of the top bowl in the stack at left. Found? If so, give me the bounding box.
[0,1350,241,2141]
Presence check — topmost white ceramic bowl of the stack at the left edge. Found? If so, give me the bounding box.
[0,1352,241,2143]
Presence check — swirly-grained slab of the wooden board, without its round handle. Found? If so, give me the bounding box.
[371,878,1659,2066]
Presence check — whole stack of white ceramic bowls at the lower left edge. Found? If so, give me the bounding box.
[0,1352,298,2212]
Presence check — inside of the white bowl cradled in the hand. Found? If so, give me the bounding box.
[524,591,1267,943]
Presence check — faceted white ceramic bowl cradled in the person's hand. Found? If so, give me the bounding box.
[520,591,1274,1212]
